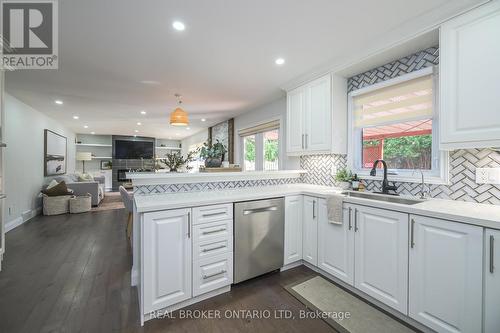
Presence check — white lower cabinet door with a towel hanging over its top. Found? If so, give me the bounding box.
[318,199,354,285]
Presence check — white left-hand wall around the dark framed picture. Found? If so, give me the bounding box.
[3,94,75,230]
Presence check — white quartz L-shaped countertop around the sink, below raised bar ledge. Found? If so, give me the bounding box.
[135,184,500,229]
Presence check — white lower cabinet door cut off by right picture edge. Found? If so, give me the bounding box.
[484,229,500,333]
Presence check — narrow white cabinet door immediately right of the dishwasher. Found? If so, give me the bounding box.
[284,195,304,265]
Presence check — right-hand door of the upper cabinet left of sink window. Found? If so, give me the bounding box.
[305,75,332,152]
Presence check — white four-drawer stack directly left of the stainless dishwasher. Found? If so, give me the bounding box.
[193,204,233,296]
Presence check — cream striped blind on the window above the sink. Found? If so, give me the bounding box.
[353,74,433,128]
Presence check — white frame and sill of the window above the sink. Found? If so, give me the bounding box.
[347,66,449,184]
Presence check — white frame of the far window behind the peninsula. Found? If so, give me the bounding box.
[237,117,285,172]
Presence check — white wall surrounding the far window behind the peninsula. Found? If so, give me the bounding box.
[234,97,300,170]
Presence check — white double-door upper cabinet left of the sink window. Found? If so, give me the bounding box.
[287,75,347,155]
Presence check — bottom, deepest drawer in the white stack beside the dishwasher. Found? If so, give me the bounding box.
[193,252,233,296]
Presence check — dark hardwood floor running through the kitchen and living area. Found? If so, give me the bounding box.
[0,210,333,333]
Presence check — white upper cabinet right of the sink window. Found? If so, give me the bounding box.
[440,1,500,150]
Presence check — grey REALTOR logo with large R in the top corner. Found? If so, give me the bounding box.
[0,0,58,70]
